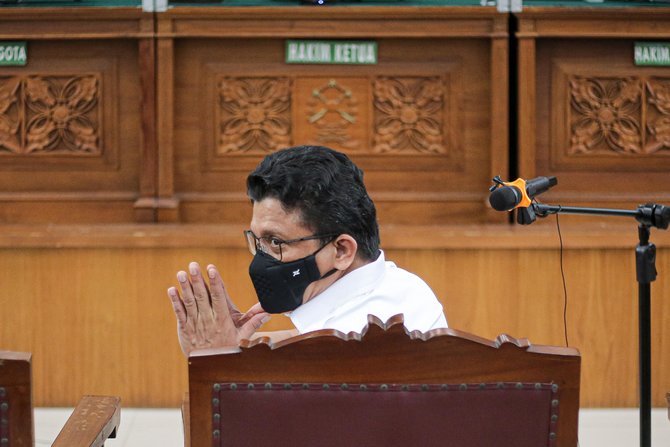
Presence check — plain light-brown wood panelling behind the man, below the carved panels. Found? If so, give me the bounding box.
[0,234,670,407]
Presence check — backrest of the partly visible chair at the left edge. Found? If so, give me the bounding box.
[0,351,35,447]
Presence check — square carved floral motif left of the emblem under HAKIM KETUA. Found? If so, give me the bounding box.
[217,77,291,154]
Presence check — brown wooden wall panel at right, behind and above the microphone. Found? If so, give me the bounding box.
[517,7,670,221]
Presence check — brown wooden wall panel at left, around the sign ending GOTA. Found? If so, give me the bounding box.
[0,8,156,224]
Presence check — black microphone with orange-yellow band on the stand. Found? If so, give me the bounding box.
[489,176,558,211]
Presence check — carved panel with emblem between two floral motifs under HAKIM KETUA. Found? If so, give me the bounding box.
[202,69,459,170]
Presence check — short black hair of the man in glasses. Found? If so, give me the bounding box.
[247,146,379,261]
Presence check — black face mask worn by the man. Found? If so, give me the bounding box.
[249,244,337,314]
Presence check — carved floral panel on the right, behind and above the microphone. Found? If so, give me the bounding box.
[568,76,670,155]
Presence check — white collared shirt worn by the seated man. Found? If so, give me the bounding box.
[288,251,447,334]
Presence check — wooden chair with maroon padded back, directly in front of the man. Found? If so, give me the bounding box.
[184,315,581,447]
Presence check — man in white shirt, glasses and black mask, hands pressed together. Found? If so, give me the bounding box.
[168,146,447,355]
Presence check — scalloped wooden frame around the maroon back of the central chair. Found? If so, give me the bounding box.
[183,315,581,447]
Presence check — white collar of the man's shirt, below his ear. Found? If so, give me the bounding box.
[288,250,386,334]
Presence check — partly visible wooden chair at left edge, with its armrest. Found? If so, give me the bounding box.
[0,351,120,447]
